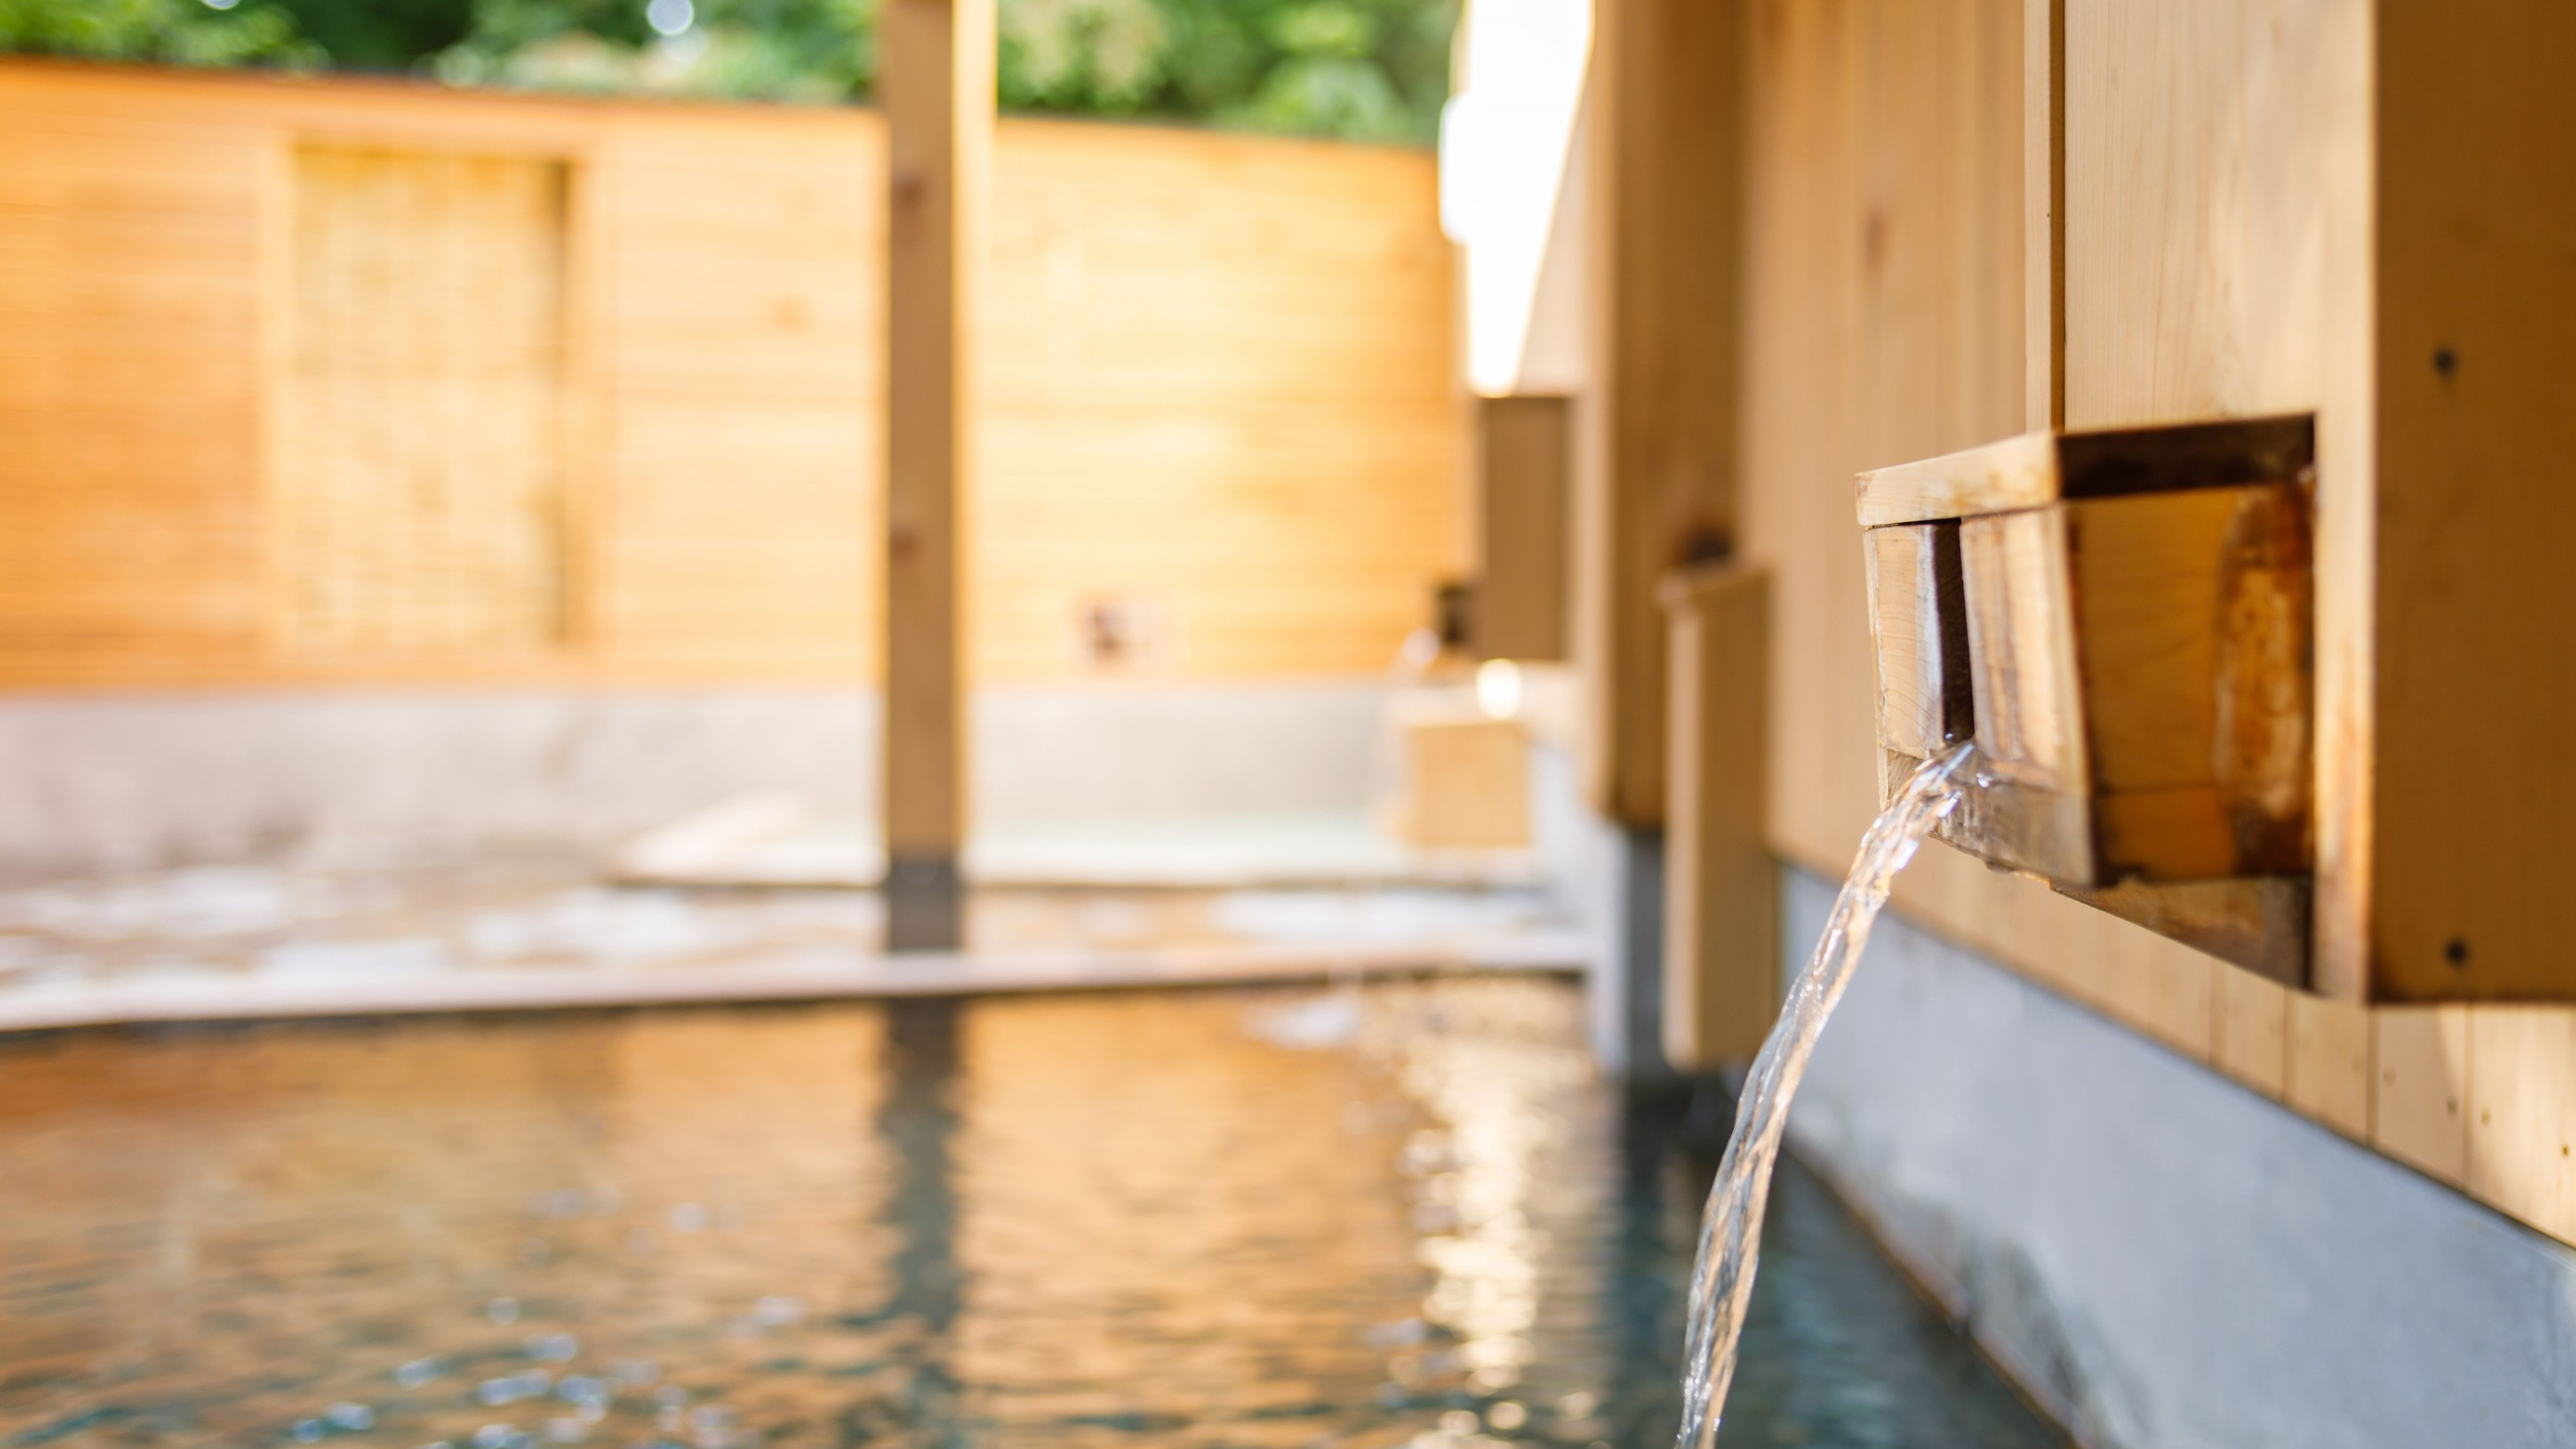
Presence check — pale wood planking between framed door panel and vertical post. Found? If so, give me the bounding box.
[585,108,886,680]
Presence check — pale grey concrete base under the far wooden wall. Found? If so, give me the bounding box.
[0,680,1386,878]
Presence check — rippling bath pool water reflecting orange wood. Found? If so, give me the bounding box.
[0,978,2060,1449]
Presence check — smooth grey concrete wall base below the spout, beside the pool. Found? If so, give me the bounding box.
[1782,870,2576,1449]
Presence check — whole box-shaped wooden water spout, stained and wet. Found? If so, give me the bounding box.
[1860,414,2314,981]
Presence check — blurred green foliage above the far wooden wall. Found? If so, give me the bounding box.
[0,0,1456,142]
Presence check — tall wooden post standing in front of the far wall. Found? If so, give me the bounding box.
[876,0,994,949]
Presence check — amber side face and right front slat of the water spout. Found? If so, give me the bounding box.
[1945,487,2311,890]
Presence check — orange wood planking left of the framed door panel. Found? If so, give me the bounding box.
[0,85,268,677]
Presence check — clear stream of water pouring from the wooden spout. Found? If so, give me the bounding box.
[1675,742,1976,1449]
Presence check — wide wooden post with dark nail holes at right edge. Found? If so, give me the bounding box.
[2370,0,2576,1001]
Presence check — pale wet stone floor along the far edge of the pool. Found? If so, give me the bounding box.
[0,859,1584,1029]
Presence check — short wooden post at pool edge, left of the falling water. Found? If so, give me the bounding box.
[1664,564,1780,1071]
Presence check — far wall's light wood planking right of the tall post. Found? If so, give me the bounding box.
[969,121,1468,680]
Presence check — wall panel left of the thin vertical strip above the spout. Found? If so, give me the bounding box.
[1744,0,2046,898]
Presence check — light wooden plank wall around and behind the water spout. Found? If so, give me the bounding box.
[1744,0,2576,1240]
